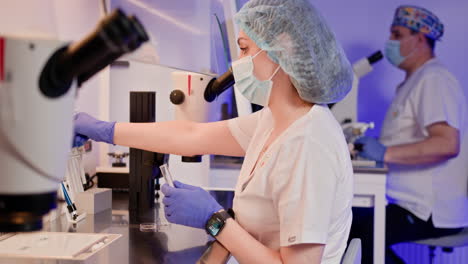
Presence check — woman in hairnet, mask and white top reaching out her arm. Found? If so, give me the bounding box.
[75,0,352,263]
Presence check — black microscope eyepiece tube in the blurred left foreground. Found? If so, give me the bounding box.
[39,9,149,98]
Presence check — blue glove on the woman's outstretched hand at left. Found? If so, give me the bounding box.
[73,113,115,144]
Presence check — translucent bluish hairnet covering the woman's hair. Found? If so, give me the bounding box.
[234,0,353,104]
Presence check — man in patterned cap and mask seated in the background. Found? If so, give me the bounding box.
[350,6,468,263]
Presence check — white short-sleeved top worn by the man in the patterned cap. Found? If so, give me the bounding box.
[380,59,468,228]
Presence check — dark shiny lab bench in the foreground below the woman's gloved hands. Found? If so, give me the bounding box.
[0,192,236,264]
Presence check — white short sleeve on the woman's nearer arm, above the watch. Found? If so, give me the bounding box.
[272,136,339,247]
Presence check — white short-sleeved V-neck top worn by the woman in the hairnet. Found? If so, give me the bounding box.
[228,105,353,263]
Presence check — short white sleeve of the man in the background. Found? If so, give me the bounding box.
[412,73,466,129]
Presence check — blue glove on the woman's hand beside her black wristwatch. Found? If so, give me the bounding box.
[161,181,223,229]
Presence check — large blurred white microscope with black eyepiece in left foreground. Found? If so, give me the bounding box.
[0,7,148,232]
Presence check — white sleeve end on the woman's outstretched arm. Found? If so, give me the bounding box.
[228,110,263,151]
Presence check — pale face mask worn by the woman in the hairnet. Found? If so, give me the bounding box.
[232,50,280,106]
